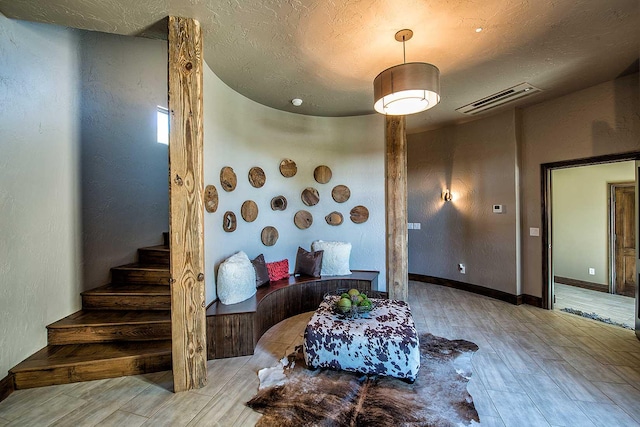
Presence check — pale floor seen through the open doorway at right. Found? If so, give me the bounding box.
[553,283,636,327]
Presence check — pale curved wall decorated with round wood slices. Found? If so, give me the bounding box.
[204,66,386,303]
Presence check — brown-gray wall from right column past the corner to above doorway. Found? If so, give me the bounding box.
[408,74,640,296]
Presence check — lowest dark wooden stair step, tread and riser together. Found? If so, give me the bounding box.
[9,340,171,389]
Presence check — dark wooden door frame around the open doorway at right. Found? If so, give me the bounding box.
[540,151,640,310]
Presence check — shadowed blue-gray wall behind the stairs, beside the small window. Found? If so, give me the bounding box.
[80,31,169,289]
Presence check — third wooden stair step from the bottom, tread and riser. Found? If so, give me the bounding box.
[82,283,171,310]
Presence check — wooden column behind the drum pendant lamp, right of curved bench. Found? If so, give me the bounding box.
[385,116,409,301]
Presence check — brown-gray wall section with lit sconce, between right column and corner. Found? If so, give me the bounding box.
[407,111,518,294]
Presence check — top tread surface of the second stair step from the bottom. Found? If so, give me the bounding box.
[47,310,171,329]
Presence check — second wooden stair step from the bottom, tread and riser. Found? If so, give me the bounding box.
[47,310,171,345]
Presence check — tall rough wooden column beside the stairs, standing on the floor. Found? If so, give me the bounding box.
[169,16,207,392]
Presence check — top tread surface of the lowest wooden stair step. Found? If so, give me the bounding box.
[10,340,171,374]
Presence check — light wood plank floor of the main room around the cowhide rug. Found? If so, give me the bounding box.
[0,282,640,427]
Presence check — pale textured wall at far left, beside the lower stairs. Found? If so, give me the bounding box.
[0,14,81,378]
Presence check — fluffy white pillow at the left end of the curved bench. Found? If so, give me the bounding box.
[218,251,256,304]
